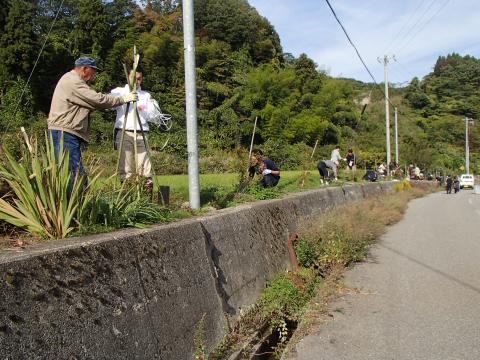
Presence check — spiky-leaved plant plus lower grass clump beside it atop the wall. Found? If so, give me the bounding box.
[0,138,170,239]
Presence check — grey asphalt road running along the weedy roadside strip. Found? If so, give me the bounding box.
[289,190,480,360]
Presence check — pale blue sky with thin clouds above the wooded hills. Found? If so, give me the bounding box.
[249,0,480,83]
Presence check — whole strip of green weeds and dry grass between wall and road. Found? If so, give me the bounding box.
[210,186,425,359]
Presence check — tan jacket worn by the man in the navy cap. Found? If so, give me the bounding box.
[48,70,123,141]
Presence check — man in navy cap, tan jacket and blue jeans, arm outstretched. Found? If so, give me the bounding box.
[48,56,137,175]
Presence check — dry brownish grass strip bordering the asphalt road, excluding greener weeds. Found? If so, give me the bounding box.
[287,188,426,351]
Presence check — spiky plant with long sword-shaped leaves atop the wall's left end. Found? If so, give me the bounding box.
[0,137,100,239]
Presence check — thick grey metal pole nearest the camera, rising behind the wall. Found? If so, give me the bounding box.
[182,0,200,209]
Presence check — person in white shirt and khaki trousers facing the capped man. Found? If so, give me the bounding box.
[110,71,158,190]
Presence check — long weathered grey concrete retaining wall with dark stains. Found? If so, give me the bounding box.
[0,183,420,359]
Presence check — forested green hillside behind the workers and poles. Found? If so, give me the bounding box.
[0,0,480,173]
